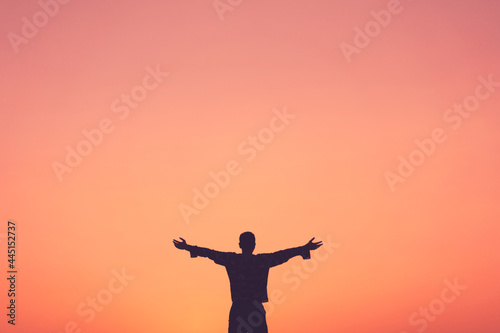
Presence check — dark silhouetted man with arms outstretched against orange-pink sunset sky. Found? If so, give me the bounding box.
[174,231,323,333]
